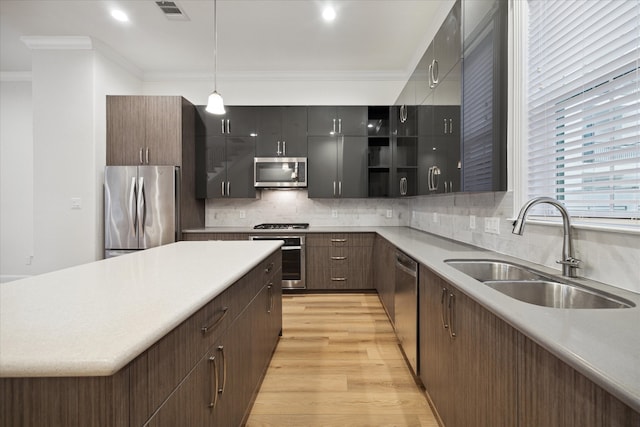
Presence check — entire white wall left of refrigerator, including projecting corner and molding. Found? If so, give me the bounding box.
[0,41,142,281]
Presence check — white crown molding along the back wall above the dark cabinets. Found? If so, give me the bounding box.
[143,70,407,82]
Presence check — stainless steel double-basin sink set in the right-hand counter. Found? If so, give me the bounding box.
[445,259,635,309]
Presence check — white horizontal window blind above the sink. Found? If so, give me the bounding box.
[527,0,640,218]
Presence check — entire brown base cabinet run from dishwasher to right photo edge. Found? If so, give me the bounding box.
[419,265,640,427]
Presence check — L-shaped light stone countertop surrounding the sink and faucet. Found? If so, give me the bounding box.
[185,226,640,412]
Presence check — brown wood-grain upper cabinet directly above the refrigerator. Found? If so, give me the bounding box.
[107,96,184,166]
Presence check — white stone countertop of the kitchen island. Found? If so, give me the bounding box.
[0,241,282,377]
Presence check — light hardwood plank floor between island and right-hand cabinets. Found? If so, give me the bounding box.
[247,293,438,427]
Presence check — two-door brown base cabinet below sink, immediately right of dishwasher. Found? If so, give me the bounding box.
[419,266,517,427]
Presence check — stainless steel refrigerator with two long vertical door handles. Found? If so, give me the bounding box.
[104,166,180,258]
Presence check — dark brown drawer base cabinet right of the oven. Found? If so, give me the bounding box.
[306,233,374,290]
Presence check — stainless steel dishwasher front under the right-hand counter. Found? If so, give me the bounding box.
[394,251,418,375]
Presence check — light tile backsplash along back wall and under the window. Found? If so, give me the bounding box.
[206,190,640,293]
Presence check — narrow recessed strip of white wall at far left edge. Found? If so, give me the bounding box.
[0,80,34,278]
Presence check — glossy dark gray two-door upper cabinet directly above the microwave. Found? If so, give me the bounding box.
[256,107,307,157]
